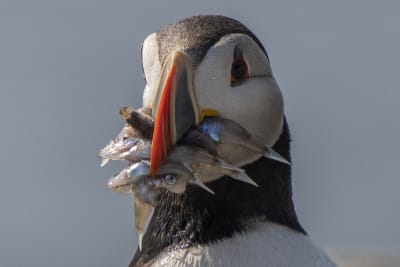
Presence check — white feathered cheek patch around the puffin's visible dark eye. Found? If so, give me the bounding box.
[194,34,283,149]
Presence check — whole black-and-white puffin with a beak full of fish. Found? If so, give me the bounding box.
[129,15,336,267]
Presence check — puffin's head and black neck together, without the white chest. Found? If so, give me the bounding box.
[131,15,304,266]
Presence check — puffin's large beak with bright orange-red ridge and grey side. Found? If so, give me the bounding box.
[150,51,201,176]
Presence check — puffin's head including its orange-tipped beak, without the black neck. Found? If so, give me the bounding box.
[142,16,284,175]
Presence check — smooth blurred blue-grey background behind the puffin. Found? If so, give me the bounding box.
[0,0,400,266]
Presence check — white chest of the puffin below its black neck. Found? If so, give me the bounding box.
[150,224,336,267]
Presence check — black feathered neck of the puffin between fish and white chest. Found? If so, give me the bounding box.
[130,122,305,266]
